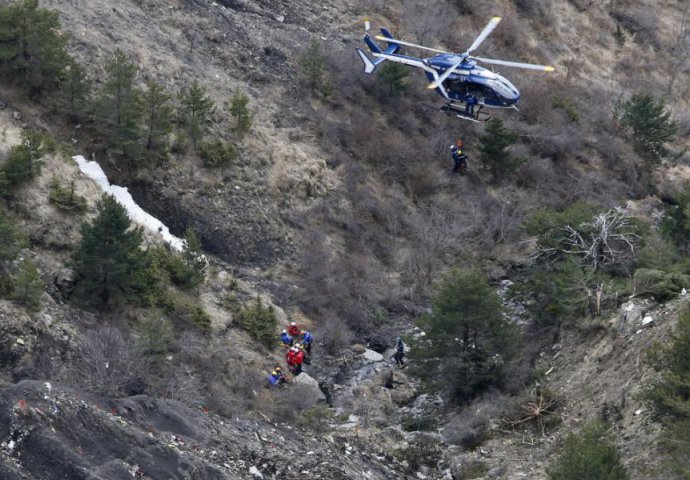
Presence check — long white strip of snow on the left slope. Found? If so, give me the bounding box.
[72,155,184,251]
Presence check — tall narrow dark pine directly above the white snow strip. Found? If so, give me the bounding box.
[96,50,143,158]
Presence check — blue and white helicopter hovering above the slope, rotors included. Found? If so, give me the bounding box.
[356,17,555,121]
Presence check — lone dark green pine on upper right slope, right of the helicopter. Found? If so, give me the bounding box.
[621,93,678,173]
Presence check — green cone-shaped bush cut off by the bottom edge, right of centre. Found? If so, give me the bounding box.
[547,422,628,480]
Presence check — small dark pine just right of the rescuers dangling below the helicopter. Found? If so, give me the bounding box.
[479,118,523,180]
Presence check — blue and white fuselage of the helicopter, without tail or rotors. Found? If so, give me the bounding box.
[424,54,520,108]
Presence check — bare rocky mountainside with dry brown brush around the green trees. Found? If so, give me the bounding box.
[0,0,690,480]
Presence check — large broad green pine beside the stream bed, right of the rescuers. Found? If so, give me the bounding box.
[411,270,519,403]
